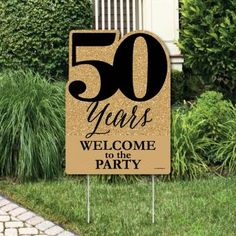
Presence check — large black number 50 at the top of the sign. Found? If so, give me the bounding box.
[69,31,168,102]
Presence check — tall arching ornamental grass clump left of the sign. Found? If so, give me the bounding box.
[0,71,64,180]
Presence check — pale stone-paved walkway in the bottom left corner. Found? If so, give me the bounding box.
[0,195,75,236]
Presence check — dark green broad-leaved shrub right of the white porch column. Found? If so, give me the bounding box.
[180,0,236,96]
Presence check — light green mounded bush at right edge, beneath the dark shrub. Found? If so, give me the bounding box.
[192,92,236,172]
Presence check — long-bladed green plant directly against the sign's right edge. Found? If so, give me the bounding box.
[170,109,208,179]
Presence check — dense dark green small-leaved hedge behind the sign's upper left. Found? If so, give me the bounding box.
[0,0,93,78]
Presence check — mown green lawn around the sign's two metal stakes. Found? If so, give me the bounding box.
[0,177,236,236]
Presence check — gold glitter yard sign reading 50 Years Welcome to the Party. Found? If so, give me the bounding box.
[66,30,170,174]
